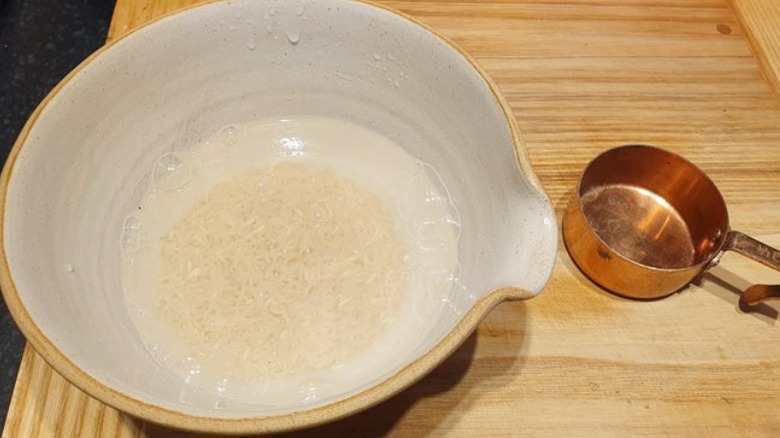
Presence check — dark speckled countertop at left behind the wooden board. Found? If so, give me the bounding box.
[0,0,115,429]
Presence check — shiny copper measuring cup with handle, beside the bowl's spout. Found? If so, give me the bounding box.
[563,145,780,305]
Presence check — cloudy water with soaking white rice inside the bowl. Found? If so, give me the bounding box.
[121,116,460,407]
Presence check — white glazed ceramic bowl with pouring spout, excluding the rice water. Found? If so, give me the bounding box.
[0,0,557,433]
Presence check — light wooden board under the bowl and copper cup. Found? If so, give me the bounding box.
[3,0,780,437]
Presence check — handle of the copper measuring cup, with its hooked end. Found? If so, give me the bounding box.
[723,231,780,306]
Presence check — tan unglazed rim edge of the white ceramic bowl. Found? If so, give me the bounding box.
[0,0,557,435]
